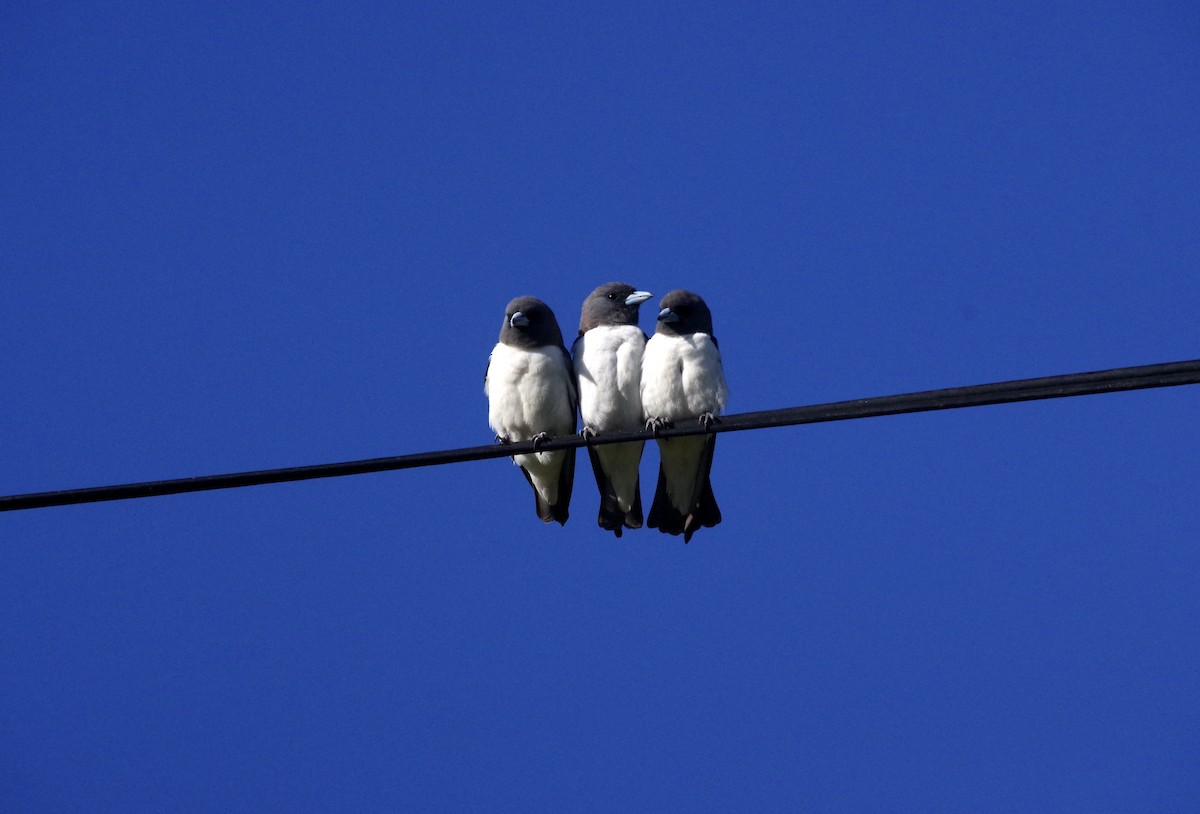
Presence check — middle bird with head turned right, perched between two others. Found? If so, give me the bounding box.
[571,282,654,538]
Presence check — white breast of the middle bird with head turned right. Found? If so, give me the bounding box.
[574,325,646,432]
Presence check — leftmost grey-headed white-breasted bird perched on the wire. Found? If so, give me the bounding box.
[484,297,578,525]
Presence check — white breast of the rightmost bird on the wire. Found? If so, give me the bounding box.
[641,334,728,421]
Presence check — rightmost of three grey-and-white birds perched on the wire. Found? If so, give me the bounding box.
[641,289,728,543]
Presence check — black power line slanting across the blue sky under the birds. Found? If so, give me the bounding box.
[0,359,1200,511]
